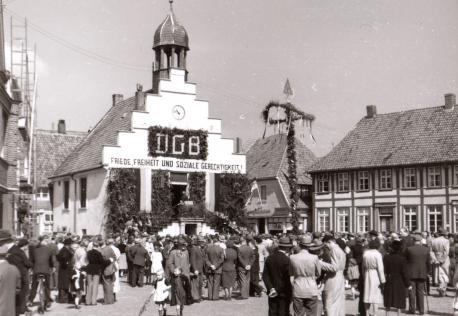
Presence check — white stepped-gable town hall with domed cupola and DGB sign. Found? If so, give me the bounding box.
[51,1,246,235]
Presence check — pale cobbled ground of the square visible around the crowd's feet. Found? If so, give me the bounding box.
[32,283,453,316]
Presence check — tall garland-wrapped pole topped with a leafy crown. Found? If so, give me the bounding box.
[261,101,315,233]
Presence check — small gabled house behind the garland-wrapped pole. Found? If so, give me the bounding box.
[246,134,316,234]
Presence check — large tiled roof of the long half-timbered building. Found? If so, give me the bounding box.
[311,106,458,172]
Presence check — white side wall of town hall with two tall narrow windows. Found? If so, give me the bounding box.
[53,168,108,235]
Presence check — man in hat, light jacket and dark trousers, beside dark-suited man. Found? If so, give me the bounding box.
[290,235,321,316]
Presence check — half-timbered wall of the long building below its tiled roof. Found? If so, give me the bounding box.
[313,164,458,233]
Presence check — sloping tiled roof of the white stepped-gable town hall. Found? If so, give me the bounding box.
[53,97,135,177]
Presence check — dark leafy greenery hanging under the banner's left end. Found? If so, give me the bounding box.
[106,168,140,234]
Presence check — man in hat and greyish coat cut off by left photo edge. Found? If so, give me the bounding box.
[0,229,21,316]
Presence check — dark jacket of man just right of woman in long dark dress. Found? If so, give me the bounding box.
[405,245,430,280]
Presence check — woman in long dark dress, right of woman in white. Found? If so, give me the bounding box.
[383,240,409,315]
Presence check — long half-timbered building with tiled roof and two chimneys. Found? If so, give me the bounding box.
[311,94,458,233]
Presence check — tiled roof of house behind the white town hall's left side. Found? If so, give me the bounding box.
[32,129,87,187]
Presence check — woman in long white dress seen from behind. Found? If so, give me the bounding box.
[363,239,385,315]
